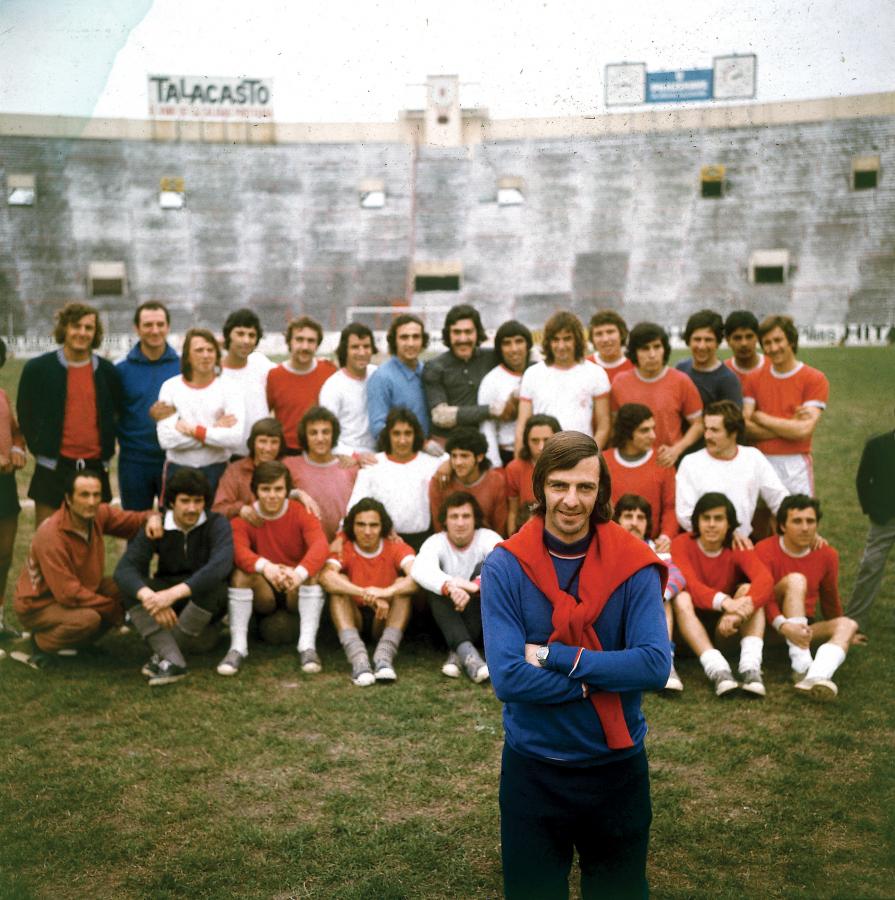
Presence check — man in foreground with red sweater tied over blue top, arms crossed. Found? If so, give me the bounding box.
[481,431,671,898]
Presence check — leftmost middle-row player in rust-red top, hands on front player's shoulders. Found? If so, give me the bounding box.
[212,418,320,525]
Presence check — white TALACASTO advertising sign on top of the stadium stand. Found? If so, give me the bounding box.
[147,75,273,121]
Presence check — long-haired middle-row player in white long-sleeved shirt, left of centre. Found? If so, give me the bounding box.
[348,406,448,552]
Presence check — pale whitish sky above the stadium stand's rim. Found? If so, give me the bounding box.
[0,0,895,122]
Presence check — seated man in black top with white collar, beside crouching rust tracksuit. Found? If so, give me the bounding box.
[115,467,233,687]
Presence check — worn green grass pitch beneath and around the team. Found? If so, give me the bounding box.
[0,348,895,900]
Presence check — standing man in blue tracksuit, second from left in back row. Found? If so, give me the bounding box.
[116,300,180,509]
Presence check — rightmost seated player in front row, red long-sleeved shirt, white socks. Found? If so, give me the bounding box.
[755,494,858,700]
